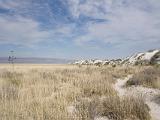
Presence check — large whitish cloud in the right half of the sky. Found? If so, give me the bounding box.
[88,8,160,42]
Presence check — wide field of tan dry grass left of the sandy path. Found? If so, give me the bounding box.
[0,65,150,120]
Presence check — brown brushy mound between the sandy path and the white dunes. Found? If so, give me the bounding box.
[126,66,160,89]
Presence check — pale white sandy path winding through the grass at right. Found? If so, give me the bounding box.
[114,75,160,120]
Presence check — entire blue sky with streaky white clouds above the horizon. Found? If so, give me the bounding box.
[0,0,160,59]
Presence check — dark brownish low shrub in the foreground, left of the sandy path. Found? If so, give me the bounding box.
[101,96,150,120]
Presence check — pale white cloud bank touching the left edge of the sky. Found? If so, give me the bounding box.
[0,16,49,44]
